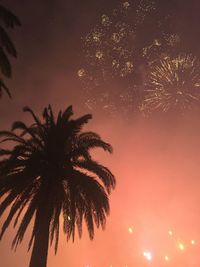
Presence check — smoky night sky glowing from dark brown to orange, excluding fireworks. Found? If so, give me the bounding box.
[0,0,200,267]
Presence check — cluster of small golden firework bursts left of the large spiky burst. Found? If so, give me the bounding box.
[77,0,180,116]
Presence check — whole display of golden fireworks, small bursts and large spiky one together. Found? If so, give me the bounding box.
[77,0,189,116]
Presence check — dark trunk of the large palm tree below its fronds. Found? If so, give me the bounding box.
[29,205,51,267]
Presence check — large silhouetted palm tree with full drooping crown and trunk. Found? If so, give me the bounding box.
[0,106,116,267]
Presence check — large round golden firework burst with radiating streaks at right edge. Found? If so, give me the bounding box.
[141,55,200,113]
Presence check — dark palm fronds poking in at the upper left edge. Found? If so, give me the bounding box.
[0,5,20,97]
